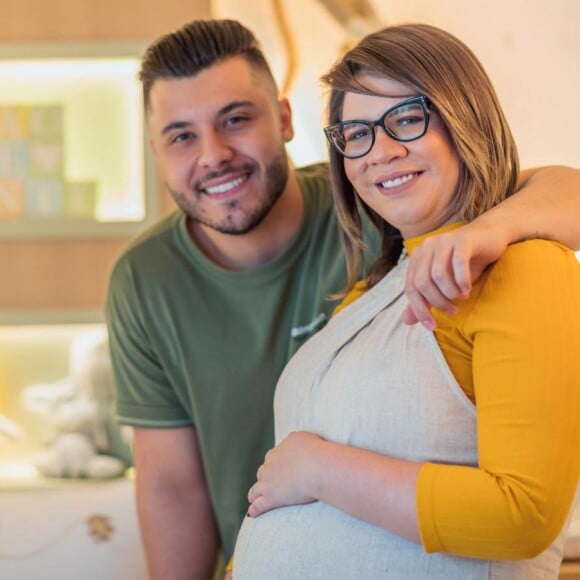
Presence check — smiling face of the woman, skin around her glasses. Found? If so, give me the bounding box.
[342,74,459,238]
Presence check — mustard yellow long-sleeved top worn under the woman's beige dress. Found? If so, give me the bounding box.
[340,224,580,559]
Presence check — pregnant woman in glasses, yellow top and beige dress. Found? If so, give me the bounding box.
[234,25,580,580]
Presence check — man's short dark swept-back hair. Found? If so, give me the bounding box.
[139,20,275,109]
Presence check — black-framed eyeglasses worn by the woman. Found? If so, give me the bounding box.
[324,95,431,159]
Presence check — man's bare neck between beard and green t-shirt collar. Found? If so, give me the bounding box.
[189,170,304,270]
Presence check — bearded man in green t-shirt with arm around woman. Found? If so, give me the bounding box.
[107,21,580,580]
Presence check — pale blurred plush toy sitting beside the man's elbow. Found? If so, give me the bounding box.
[21,332,131,478]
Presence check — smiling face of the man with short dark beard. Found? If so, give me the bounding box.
[148,57,293,234]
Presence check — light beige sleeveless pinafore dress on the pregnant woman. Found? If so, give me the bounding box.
[234,260,563,580]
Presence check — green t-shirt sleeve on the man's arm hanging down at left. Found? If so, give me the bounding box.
[105,258,192,428]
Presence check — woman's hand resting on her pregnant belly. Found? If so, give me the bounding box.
[248,431,325,517]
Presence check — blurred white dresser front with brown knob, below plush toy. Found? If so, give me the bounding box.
[0,477,146,580]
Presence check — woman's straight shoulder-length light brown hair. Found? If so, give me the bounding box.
[322,24,519,291]
